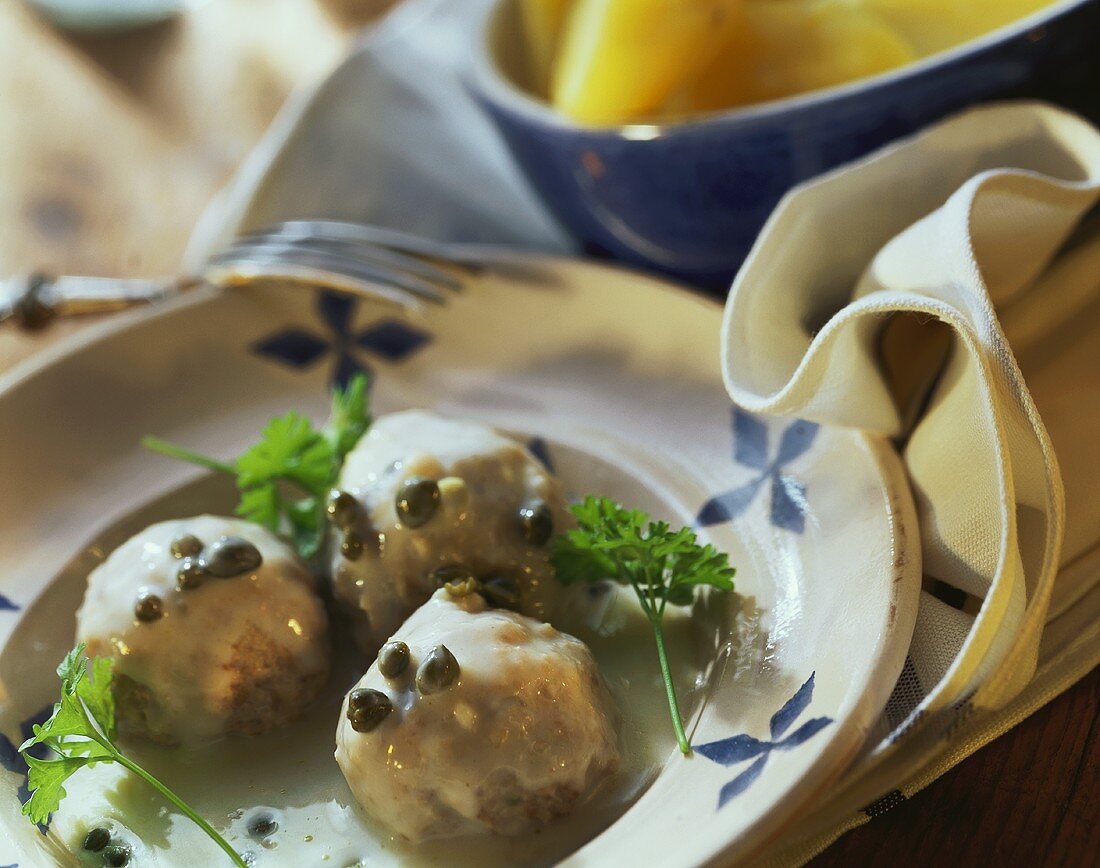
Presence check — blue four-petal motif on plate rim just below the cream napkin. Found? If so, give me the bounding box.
[695,407,818,534]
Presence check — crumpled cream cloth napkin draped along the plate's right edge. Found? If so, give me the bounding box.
[723,103,1100,865]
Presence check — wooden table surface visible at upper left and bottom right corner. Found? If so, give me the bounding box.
[0,0,1100,867]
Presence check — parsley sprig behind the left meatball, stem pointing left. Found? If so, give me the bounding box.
[142,374,372,560]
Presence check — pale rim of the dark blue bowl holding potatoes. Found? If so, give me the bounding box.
[471,0,1098,135]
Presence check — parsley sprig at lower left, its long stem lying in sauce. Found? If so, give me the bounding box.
[19,644,245,868]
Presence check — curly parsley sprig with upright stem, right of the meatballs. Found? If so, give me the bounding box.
[553,497,735,756]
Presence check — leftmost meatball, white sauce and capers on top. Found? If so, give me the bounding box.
[77,516,331,744]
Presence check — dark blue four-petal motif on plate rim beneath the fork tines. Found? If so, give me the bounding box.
[252,292,431,386]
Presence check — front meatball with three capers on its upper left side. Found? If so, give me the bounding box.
[336,590,620,840]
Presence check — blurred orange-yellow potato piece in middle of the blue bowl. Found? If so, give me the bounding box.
[682,0,917,113]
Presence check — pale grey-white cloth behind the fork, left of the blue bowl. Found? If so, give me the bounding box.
[184,0,575,270]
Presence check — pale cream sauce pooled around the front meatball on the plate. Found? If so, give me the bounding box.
[53,587,702,868]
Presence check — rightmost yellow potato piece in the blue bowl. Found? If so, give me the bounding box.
[860,0,1051,55]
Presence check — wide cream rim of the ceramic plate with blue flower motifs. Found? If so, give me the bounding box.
[0,255,920,866]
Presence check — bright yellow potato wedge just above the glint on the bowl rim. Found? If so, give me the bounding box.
[550,0,739,123]
